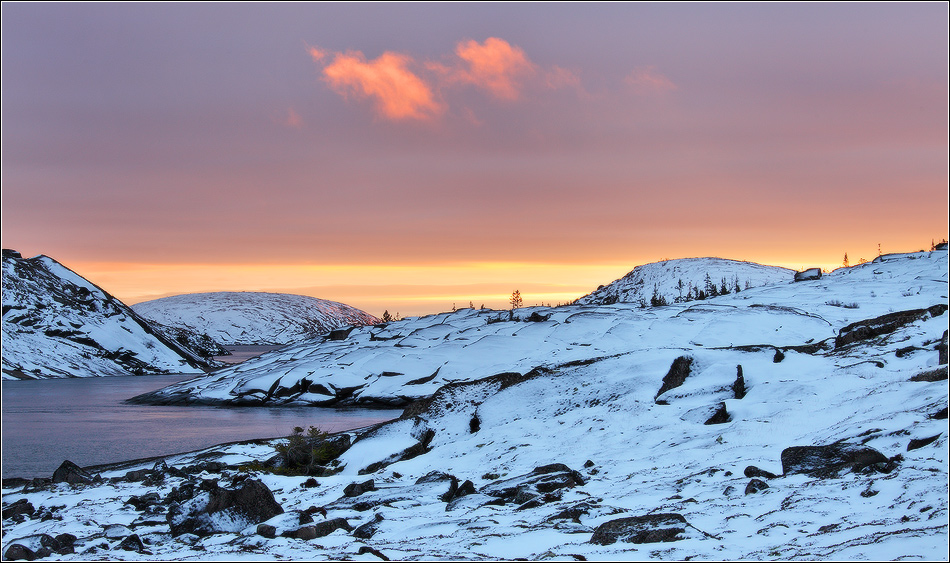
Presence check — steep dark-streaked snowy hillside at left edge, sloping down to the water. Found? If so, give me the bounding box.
[3,249,211,379]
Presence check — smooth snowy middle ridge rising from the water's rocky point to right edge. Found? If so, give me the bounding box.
[136,251,947,407]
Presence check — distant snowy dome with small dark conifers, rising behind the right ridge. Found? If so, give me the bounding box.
[577,258,795,306]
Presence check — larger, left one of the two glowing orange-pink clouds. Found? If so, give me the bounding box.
[322,47,443,121]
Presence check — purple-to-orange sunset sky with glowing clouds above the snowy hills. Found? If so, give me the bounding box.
[0,2,950,316]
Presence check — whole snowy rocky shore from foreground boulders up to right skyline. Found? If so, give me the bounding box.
[3,250,950,561]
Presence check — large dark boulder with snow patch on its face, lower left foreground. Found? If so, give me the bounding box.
[166,479,284,536]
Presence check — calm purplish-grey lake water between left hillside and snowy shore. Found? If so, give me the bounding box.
[0,375,402,478]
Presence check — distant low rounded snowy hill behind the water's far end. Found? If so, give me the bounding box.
[132,291,380,345]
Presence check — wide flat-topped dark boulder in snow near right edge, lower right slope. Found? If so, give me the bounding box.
[782,442,888,478]
